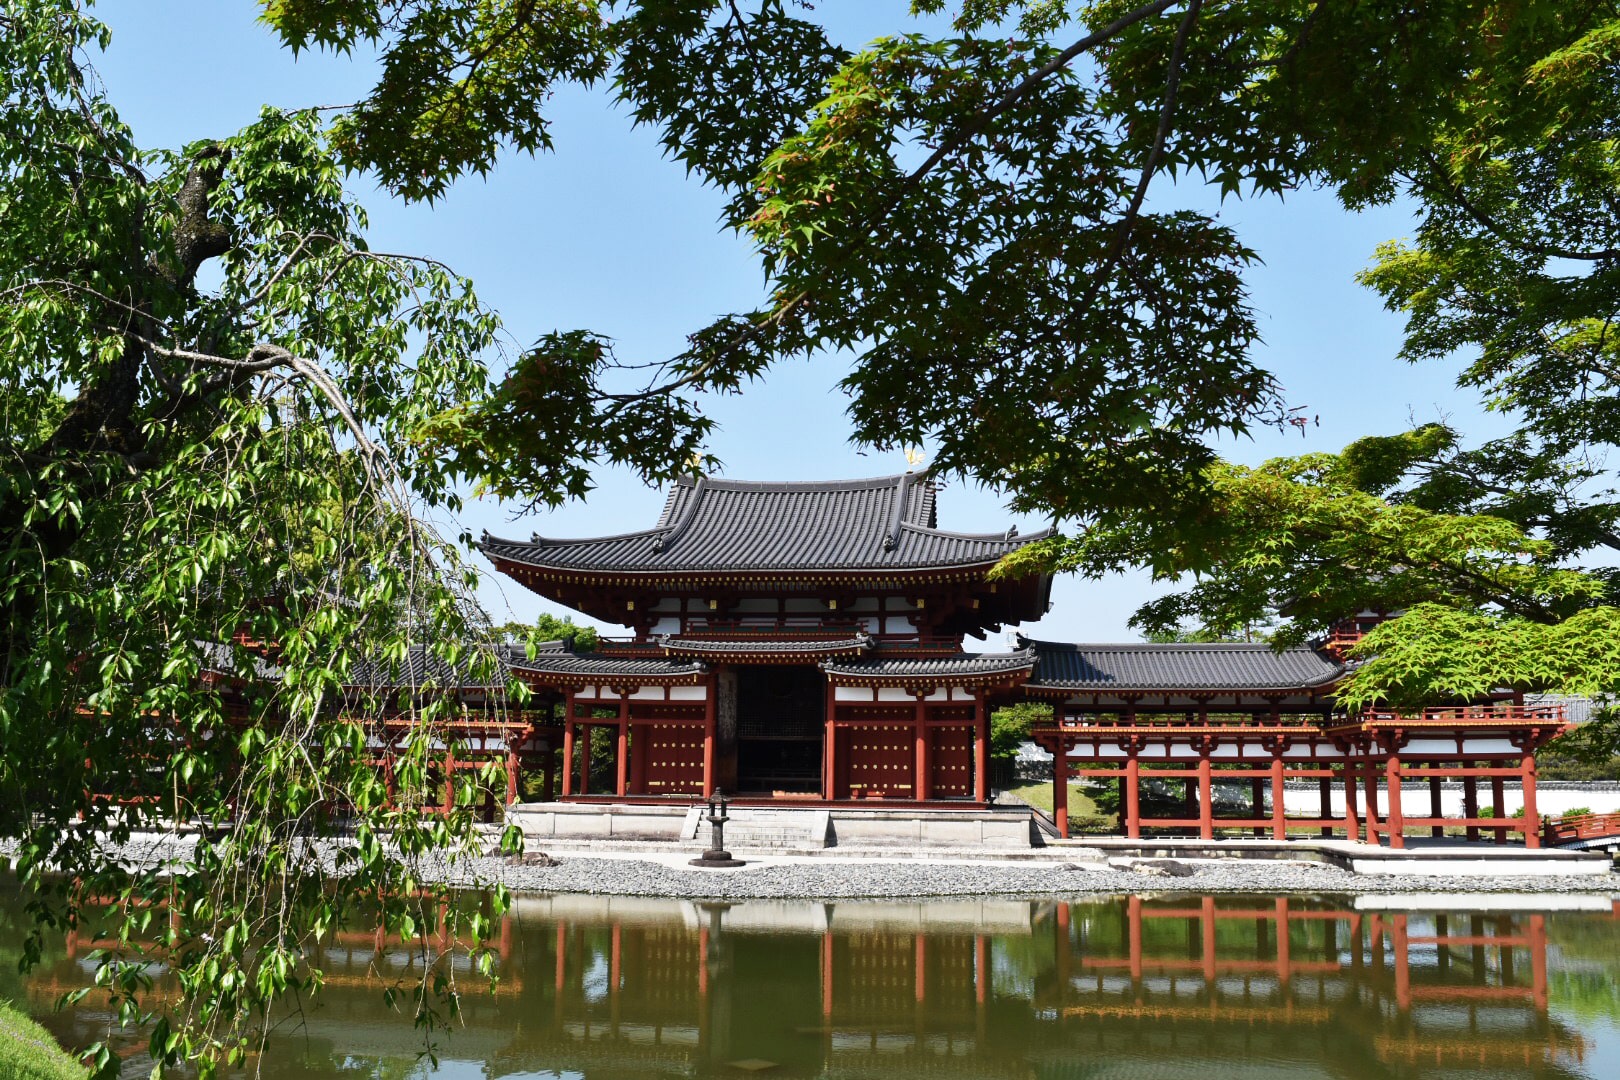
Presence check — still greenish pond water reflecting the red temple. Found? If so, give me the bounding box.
[9,894,1620,1080]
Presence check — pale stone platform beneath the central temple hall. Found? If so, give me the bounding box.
[507,803,1037,852]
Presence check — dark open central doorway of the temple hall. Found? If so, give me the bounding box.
[737,664,826,795]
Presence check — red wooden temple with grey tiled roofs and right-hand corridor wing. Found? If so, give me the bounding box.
[483,473,1565,847]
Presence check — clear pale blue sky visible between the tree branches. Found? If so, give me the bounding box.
[97,0,1477,641]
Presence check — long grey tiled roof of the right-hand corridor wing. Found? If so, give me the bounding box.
[1029,641,1345,691]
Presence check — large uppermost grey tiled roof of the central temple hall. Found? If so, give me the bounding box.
[481,473,1047,573]
